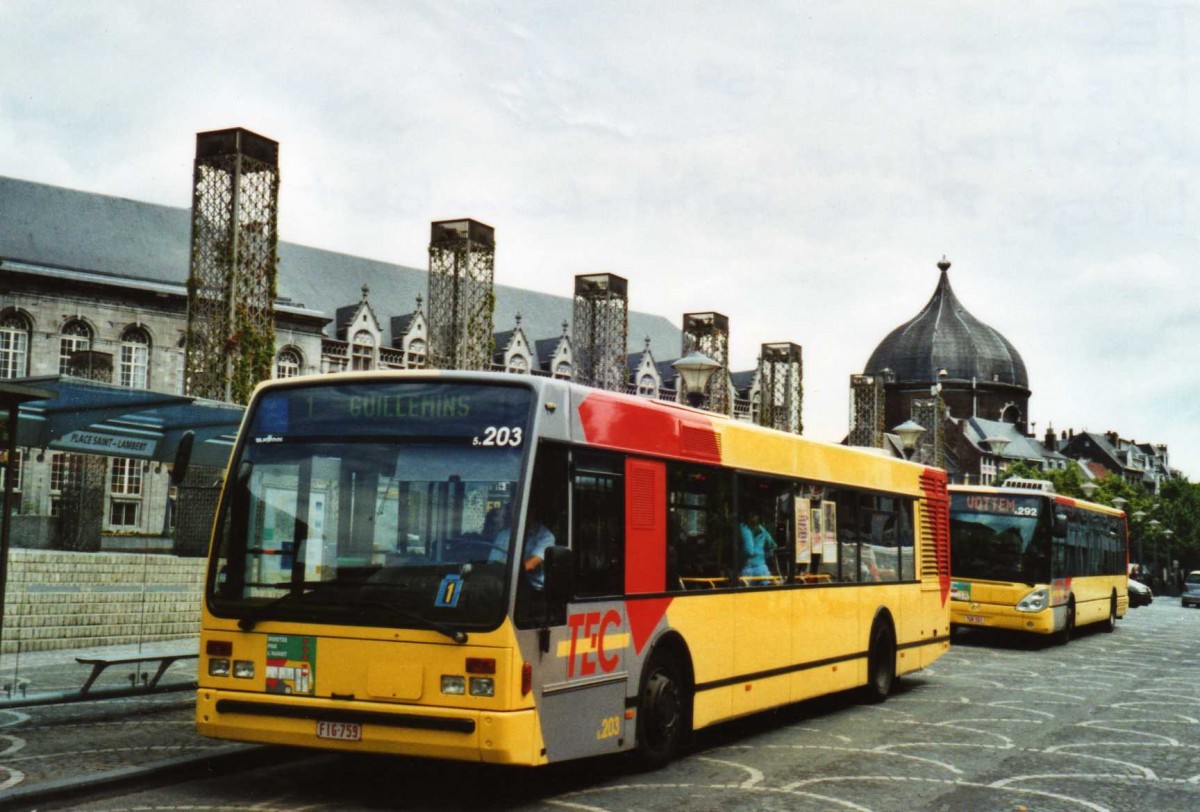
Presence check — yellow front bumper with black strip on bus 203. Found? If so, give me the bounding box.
[196,688,546,765]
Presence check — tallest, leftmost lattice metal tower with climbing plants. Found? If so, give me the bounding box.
[184,127,280,403]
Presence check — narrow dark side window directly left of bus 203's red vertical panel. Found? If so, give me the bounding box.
[571,450,625,597]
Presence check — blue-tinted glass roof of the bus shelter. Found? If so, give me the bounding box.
[10,375,245,468]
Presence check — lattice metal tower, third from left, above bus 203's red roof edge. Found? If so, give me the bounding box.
[571,273,629,391]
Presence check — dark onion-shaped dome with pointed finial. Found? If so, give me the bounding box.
[865,257,1030,390]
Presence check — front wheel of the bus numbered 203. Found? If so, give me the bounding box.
[637,650,691,769]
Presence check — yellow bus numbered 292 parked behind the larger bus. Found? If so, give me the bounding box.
[950,477,1129,643]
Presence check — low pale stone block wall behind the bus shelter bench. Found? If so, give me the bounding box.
[2,548,205,654]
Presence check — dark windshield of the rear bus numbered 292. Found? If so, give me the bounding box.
[950,493,1050,584]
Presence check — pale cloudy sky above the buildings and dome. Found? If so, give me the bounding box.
[0,0,1200,481]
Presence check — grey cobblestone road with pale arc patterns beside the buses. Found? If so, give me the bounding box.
[0,599,1200,812]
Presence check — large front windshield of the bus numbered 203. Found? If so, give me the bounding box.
[209,380,533,631]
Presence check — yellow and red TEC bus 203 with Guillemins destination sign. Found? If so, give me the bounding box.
[196,372,950,765]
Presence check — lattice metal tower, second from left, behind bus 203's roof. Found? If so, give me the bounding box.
[427,218,496,369]
